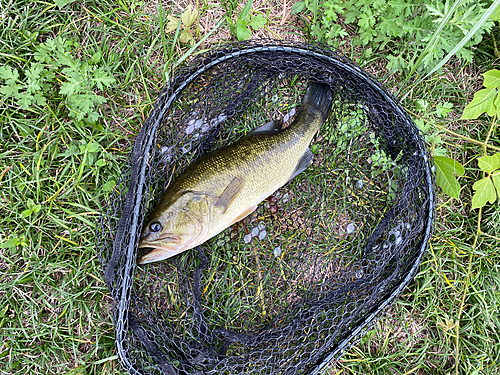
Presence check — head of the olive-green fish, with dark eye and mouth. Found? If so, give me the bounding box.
[137,191,213,264]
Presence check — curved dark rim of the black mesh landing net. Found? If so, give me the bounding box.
[96,41,435,374]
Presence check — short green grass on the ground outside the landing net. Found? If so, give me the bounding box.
[0,0,500,374]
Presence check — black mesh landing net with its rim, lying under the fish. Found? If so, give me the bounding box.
[97,42,434,374]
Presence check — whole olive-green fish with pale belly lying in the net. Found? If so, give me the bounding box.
[137,81,333,264]
